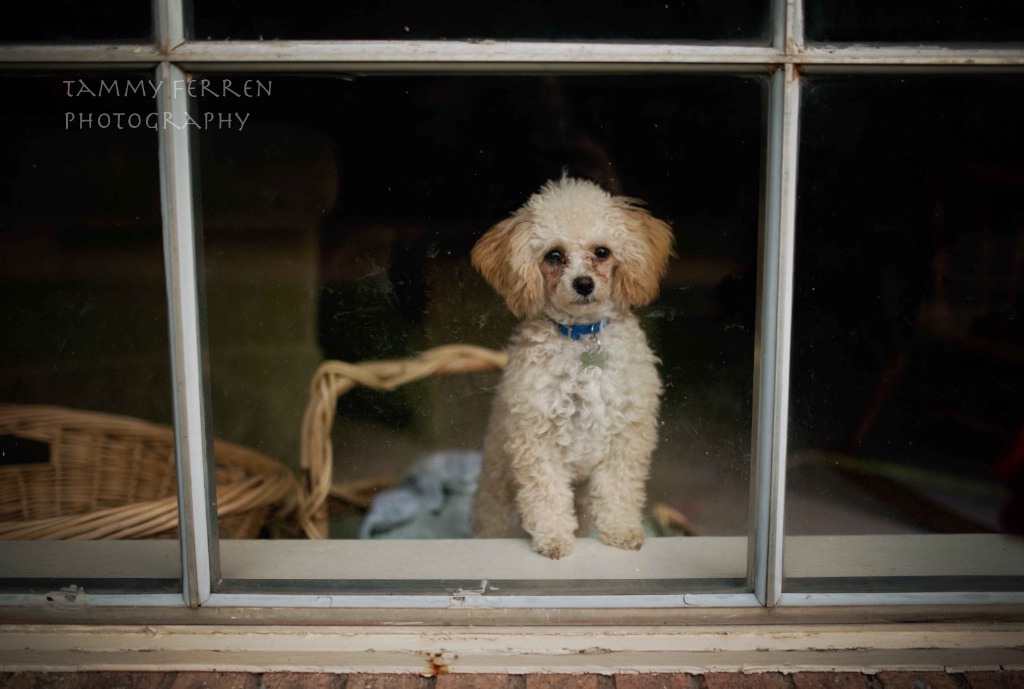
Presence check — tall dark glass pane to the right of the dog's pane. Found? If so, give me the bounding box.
[786,76,1024,590]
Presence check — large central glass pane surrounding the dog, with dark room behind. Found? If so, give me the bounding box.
[199,76,765,586]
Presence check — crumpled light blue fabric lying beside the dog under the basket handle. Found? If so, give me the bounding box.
[359,450,481,539]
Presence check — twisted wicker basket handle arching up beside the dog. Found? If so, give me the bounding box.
[295,345,508,539]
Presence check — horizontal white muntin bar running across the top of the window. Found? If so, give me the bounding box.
[0,41,1024,74]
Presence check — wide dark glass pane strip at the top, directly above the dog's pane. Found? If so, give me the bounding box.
[194,0,769,44]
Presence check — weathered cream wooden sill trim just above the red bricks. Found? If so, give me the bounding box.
[0,623,1024,675]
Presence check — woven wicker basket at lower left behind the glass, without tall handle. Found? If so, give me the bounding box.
[0,405,296,541]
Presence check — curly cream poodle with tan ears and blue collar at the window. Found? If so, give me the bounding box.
[471,176,673,559]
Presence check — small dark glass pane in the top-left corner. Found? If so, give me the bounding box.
[0,0,153,43]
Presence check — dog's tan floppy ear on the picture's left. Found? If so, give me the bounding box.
[470,211,544,318]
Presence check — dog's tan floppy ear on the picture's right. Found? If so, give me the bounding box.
[612,197,675,306]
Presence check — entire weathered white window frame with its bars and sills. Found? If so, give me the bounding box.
[0,0,1024,672]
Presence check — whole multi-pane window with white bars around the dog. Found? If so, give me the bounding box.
[0,1,1024,651]
